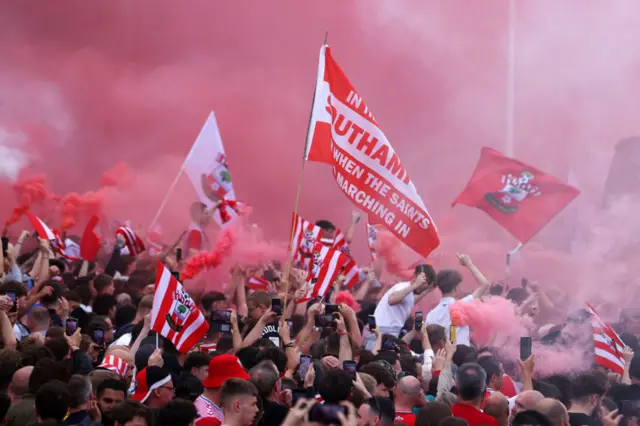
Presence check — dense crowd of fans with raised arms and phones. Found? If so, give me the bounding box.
[0,216,640,426]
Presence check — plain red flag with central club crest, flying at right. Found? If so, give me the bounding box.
[453,147,580,244]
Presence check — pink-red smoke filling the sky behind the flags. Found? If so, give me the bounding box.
[0,0,640,316]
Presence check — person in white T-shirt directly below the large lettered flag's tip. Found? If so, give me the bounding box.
[366,265,436,342]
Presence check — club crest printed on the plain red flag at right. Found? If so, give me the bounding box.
[484,171,542,214]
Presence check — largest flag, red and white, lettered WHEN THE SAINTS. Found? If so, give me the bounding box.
[306,45,440,257]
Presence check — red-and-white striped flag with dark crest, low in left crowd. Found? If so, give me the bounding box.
[151,262,209,353]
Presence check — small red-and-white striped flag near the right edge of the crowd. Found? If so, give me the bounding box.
[587,303,626,375]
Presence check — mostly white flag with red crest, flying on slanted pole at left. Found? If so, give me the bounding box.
[183,112,238,225]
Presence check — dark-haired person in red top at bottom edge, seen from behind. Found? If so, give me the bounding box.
[451,363,499,426]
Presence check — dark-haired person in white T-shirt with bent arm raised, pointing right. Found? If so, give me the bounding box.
[427,254,491,346]
